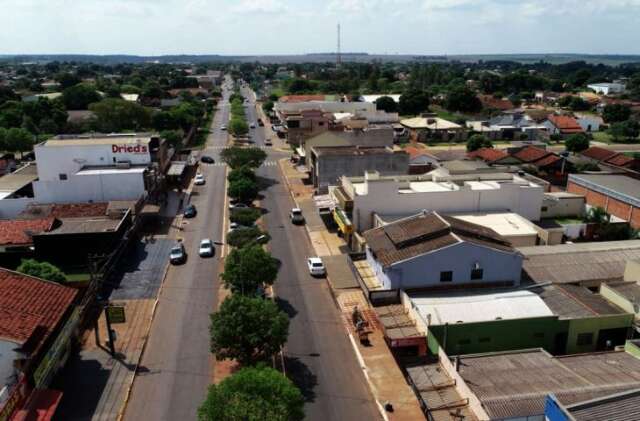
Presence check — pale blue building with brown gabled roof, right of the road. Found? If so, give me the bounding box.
[363,212,522,290]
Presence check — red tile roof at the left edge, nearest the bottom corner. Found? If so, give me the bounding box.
[0,268,78,353]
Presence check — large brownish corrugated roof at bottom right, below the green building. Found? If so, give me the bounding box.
[459,349,640,419]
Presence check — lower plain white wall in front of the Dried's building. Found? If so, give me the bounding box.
[33,172,145,203]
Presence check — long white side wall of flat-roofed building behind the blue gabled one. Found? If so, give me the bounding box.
[353,176,543,231]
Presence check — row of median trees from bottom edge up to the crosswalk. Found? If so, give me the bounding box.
[198,147,304,421]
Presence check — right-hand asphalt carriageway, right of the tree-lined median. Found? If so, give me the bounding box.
[243,90,380,421]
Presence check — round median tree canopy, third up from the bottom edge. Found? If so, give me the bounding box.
[221,244,278,295]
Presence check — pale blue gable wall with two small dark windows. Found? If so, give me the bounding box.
[376,242,522,289]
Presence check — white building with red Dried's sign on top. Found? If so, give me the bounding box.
[33,134,164,203]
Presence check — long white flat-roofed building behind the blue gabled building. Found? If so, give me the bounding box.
[334,167,544,231]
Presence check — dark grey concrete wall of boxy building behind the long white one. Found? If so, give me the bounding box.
[311,149,409,188]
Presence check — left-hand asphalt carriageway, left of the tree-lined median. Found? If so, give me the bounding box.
[125,83,229,421]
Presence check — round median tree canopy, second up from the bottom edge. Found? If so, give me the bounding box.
[209,296,289,365]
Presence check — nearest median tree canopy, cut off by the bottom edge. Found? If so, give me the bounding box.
[198,367,304,421]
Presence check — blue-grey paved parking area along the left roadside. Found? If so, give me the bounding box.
[110,238,175,300]
